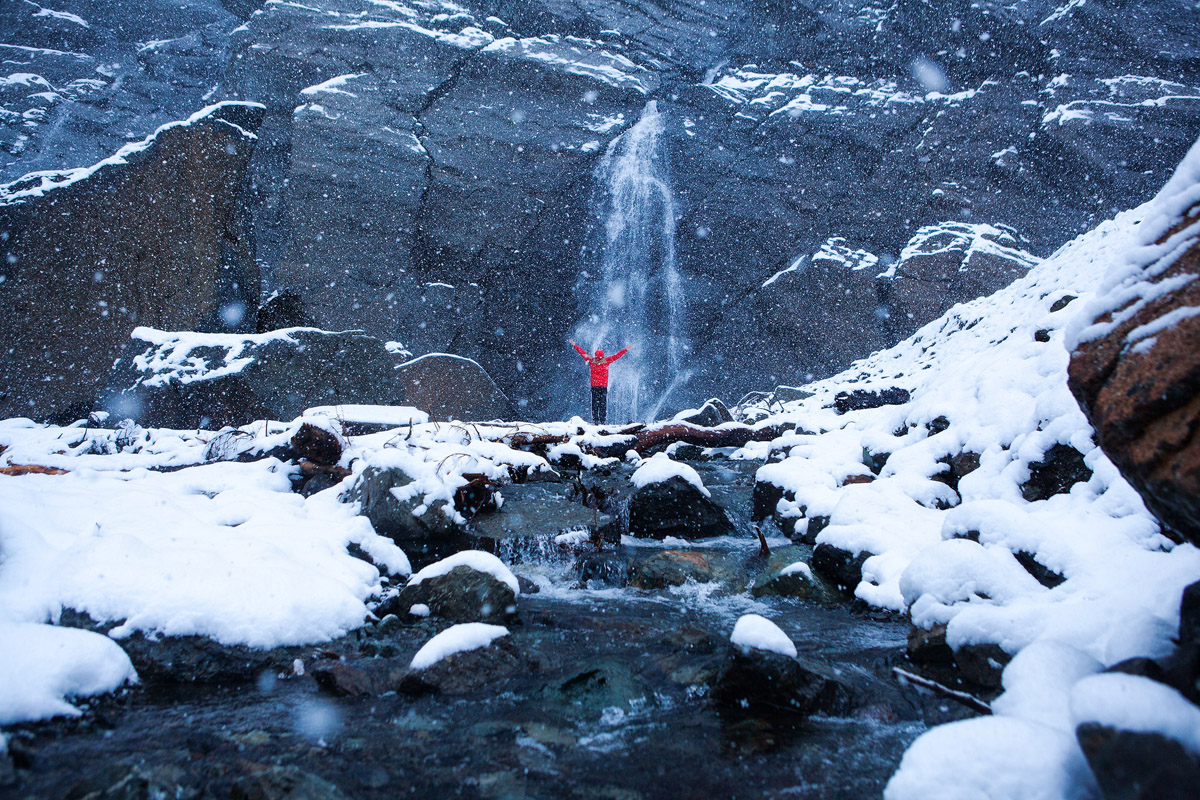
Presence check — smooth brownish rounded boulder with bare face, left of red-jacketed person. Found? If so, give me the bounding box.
[396,353,516,420]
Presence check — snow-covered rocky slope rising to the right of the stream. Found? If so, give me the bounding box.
[750,136,1200,800]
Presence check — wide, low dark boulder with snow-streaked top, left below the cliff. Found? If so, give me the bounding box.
[104,327,404,428]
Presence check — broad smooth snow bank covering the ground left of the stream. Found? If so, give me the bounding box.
[0,420,410,650]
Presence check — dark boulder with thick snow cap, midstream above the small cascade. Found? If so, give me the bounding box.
[629,453,733,539]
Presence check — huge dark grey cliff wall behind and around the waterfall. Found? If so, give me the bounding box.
[5,0,1200,415]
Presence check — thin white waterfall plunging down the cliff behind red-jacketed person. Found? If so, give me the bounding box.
[576,101,691,422]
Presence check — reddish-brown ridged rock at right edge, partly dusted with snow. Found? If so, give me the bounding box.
[1069,206,1200,543]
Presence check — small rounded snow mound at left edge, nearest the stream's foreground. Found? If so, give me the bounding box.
[0,622,138,729]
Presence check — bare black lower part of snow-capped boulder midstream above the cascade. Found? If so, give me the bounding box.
[629,477,734,539]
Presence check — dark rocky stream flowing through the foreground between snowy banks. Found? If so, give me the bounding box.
[0,459,971,798]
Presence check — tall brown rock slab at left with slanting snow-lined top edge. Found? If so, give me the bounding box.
[0,104,262,428]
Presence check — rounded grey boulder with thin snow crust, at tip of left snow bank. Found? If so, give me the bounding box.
[377,551,521,622]
